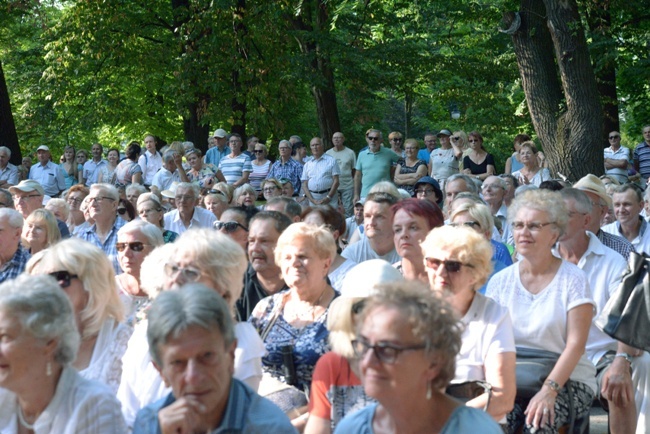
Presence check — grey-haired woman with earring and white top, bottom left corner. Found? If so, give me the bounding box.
[0,275,126,434]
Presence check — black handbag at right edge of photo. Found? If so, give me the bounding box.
[596,252,650,351]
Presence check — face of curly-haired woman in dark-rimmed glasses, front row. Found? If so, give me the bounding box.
[357,306,432,402]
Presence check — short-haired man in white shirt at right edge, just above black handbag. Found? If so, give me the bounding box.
[602,184,650,254]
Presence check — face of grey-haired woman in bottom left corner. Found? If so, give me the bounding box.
[0,309,54,392]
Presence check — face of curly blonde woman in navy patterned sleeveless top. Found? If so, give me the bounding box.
[279,237,332,289]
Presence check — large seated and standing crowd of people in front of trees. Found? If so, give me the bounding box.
[0,126,650,434]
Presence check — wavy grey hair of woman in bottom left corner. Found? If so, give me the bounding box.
[0,274,80,366]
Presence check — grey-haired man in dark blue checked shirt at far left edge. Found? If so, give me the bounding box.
[0,208,30,283]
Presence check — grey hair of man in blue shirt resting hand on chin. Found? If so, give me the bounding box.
[147,283,235,367]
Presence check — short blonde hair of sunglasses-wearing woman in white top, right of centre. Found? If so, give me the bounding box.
[421,225,493,291]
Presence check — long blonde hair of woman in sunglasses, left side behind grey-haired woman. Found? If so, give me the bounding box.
[27,239,124,338]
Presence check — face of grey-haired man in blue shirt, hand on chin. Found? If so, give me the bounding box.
[155,326,237,424]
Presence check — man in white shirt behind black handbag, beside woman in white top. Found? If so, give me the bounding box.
[557,188,650,434]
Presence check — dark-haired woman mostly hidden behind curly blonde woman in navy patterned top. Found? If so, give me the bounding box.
[302,205,357,292]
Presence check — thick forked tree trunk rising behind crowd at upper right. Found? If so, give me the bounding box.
[504,0,604,181]
